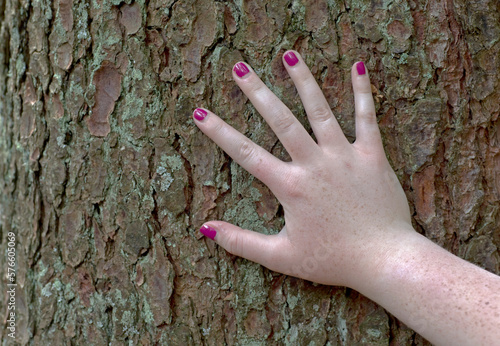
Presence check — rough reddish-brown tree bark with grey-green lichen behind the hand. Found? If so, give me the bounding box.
[0,0,500,345]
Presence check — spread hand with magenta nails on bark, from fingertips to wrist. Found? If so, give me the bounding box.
[193,51,414,289]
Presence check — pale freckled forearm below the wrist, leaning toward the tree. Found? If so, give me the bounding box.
[357,228,500,345]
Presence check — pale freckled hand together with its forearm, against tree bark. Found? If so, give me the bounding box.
[194,51,500,345]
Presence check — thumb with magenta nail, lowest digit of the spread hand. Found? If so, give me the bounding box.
[200,221,288,272]
